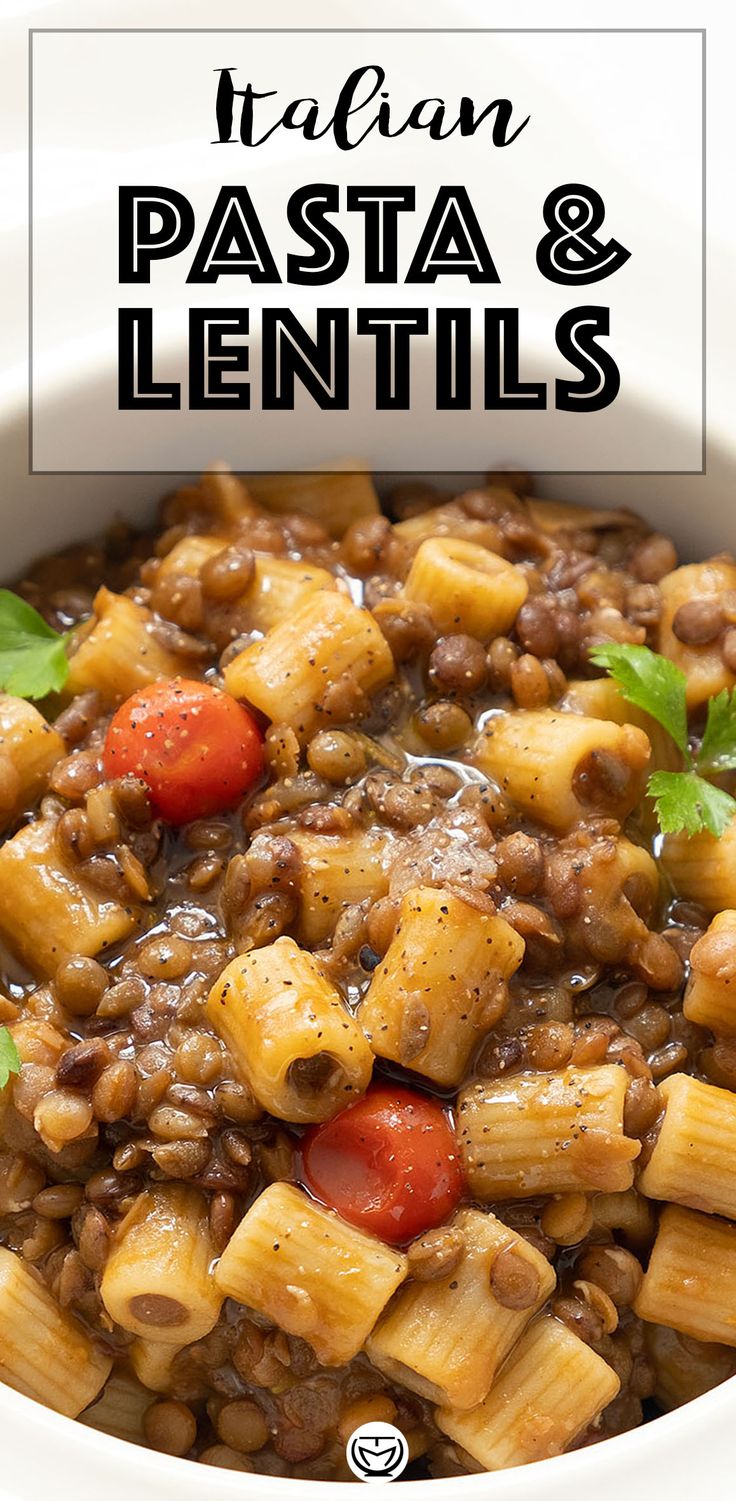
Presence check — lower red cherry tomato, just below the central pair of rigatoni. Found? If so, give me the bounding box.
[302,1084,463,1246]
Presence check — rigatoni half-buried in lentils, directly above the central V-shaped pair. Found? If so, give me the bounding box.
[290,829,395,947]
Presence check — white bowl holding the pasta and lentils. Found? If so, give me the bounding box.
[0,366,736,1501]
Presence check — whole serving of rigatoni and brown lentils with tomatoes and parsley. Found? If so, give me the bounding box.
[0,470,736,1480]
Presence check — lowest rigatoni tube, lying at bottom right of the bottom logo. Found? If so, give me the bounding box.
[436,1316,620,1469]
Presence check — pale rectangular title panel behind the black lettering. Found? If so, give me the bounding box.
[33,23,701,471]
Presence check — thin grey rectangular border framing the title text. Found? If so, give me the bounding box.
[29,26,707,477]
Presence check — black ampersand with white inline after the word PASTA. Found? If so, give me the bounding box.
[536,183,631,287]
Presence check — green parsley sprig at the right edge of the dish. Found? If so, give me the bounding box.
[590,642,736,839]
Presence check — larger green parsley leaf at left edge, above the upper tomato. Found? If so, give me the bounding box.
[0,588,69,698]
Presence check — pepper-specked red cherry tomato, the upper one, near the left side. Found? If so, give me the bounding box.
[104,677,263,824]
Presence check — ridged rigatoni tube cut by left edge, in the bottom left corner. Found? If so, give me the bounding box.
[0,1247,113,1417]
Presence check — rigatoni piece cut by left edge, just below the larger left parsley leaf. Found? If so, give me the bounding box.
[0,693,66,829]
